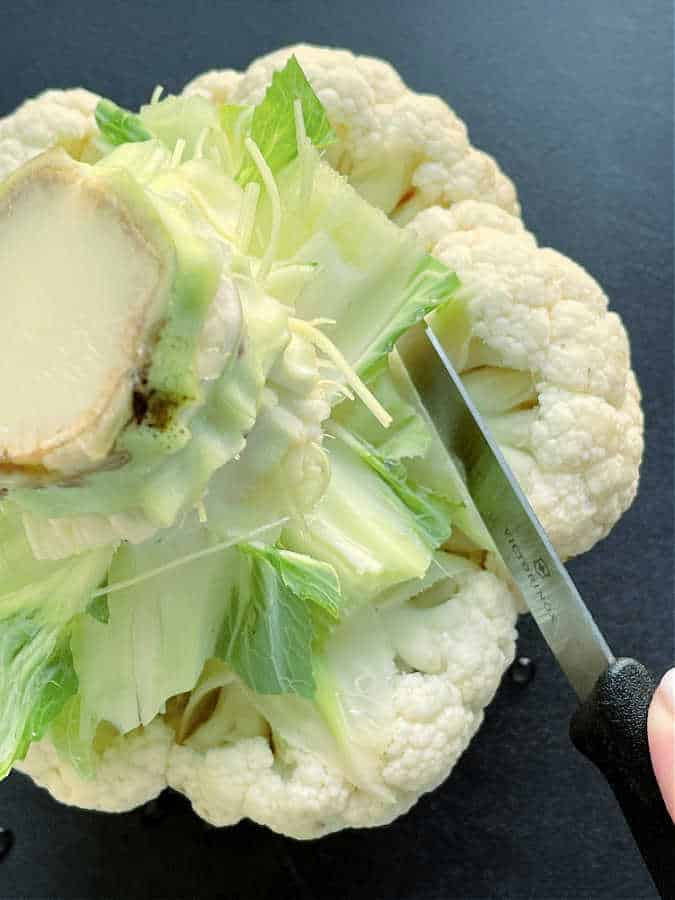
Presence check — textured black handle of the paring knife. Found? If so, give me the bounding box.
[570,659,675,900]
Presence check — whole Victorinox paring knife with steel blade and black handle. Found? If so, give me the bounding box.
[397,322,675,900]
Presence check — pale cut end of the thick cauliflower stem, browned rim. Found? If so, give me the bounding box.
[0,150,172,473]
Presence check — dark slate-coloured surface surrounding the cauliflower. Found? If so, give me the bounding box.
[0,0,675,900]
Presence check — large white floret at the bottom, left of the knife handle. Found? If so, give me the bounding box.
[168,562,516,838]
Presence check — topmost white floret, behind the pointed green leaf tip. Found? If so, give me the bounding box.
[185,44,519,223]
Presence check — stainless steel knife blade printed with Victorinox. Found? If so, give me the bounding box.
[397,323,614,699]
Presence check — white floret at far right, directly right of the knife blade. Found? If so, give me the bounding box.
[410,201,643,557]
